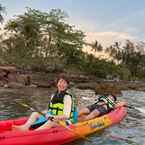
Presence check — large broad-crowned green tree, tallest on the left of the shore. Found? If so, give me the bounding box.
[3,8,84,70]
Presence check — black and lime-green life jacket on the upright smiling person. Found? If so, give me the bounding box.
[48,91,75,122]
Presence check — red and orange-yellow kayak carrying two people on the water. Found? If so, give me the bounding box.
[0,107,127,145]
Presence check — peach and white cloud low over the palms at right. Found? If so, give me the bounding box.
[69,14,138,47]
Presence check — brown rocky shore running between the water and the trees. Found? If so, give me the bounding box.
[0,66,145,93]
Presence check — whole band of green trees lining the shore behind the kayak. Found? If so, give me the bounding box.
[0,5,145,80]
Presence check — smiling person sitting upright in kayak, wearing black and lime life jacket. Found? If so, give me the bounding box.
[13,75,75,131]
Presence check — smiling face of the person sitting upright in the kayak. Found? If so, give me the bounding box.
[57,78,68,91]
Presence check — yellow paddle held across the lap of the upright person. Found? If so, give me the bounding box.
[16,102,92,143]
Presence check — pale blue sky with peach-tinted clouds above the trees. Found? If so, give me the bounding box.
[0,0,145,46]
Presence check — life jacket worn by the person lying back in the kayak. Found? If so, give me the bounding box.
[98,95,116,109]
